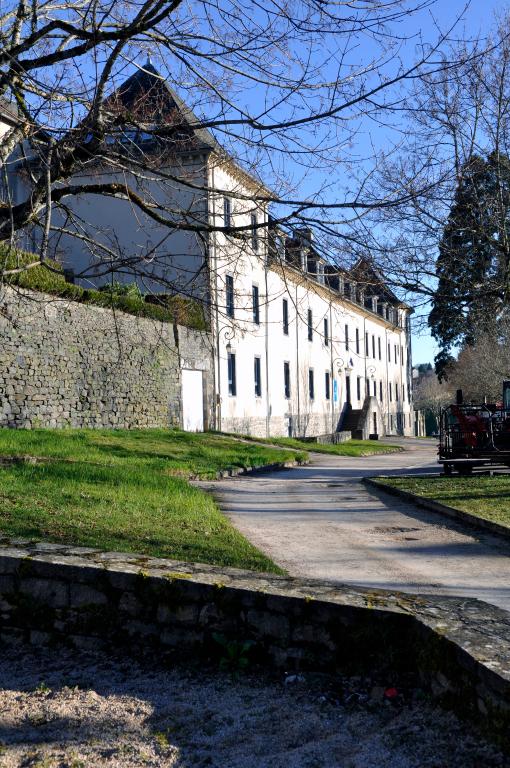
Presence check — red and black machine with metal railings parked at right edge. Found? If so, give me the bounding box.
[439,381,510,475]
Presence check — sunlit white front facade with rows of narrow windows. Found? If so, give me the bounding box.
[210,158,414,436]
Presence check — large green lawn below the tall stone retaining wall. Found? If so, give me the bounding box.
[0,429,305,572]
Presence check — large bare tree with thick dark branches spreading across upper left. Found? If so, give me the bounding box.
[0,0,478,304]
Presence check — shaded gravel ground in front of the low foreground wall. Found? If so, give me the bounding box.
[0,647,510,768]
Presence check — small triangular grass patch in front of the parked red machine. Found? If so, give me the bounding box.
[377,475,510,527]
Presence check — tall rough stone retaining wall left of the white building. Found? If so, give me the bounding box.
[0,287,213,428]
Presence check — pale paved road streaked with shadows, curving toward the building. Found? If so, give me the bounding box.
[203,439,510,610]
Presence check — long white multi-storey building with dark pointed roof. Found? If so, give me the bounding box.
[1,65,414,437]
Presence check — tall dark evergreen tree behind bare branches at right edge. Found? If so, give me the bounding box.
[429,152,510,377]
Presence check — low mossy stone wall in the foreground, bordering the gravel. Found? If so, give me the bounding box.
[0,539,510,747]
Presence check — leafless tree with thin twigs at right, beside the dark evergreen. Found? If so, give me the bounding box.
[352,16,510,336]
